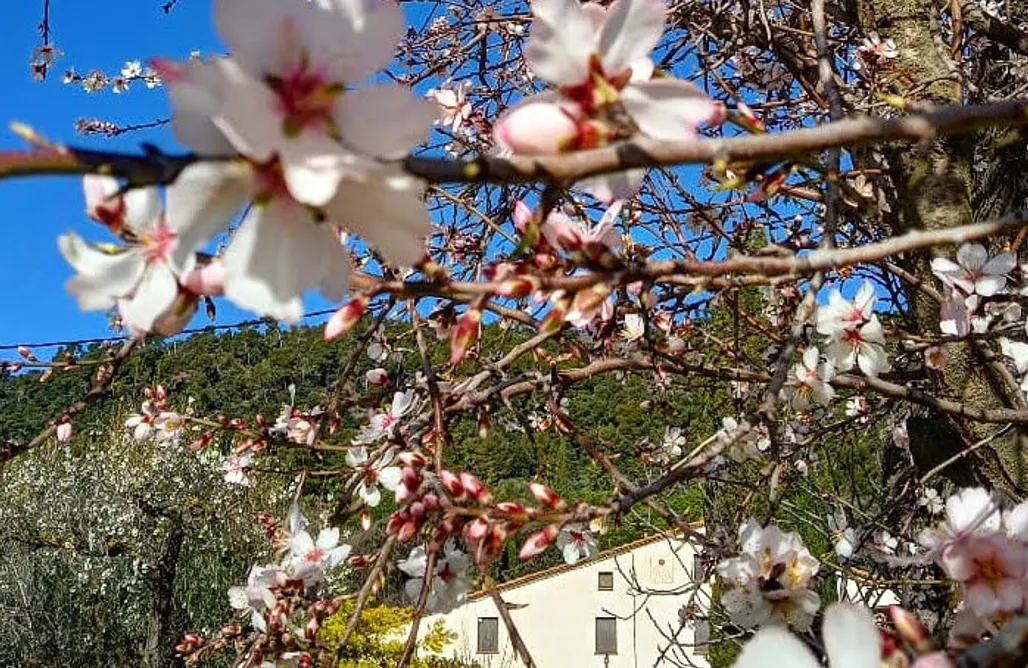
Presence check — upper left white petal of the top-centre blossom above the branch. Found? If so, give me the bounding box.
[524,0,596,85]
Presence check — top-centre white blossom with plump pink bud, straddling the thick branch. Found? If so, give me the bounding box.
[494,0,720,201]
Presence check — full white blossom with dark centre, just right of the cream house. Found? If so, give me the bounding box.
[718,519,820,631]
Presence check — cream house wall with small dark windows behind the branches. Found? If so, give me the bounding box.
[421,535,710,668]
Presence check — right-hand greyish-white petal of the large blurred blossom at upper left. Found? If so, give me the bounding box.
[335,84,436,160]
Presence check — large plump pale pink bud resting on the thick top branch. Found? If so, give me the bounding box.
[492,102,581,155]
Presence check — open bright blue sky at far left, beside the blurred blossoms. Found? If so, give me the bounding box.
[0,0,228,344]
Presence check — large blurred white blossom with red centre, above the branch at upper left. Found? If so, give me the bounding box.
[213,0,434,207]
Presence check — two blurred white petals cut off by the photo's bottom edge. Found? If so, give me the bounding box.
[733,603,882,668]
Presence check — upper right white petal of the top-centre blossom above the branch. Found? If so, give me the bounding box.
[598,0,667,75]
